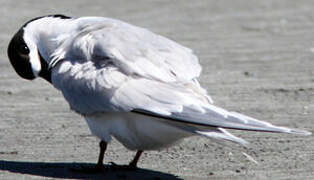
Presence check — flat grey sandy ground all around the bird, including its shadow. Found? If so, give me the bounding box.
[0,0,314,180]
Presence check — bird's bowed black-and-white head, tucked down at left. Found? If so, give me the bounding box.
[7,15,70,82]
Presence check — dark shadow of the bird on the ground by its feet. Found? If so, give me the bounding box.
[0,160,180,179]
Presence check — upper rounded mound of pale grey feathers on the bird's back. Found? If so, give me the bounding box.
[60,18,201,82]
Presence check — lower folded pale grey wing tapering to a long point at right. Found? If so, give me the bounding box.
[112,79,309,134]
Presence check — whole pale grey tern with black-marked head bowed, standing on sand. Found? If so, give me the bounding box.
[7,14,311,172]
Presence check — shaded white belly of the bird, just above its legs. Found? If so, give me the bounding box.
[85,113,193,150]
